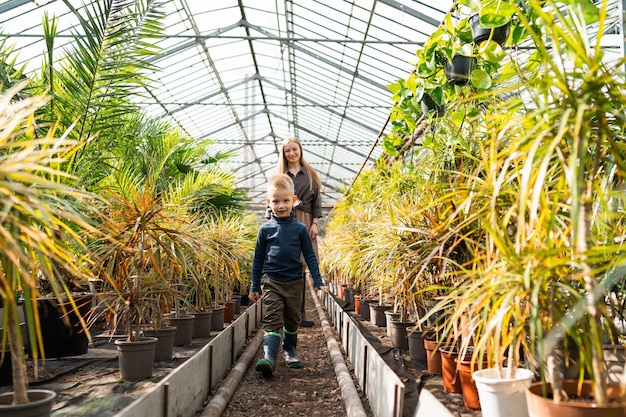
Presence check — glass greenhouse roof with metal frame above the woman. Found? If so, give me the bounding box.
[0,0,623,213]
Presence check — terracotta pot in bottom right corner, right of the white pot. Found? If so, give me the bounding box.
[526,380,626,417]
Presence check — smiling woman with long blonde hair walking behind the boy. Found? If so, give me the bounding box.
[277,137,322,327]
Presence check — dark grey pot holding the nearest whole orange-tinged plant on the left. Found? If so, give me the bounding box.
[115,337,157,381]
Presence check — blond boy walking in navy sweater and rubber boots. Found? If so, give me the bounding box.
[248,174,328,378]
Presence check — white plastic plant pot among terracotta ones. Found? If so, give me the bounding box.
[472,368,535,417]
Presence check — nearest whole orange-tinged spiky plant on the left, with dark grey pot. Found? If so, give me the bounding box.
[91,172,193,379]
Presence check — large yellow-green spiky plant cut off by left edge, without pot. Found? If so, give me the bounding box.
[0,86,95,404]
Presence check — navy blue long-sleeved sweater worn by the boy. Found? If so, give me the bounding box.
[250,212,324,292]
